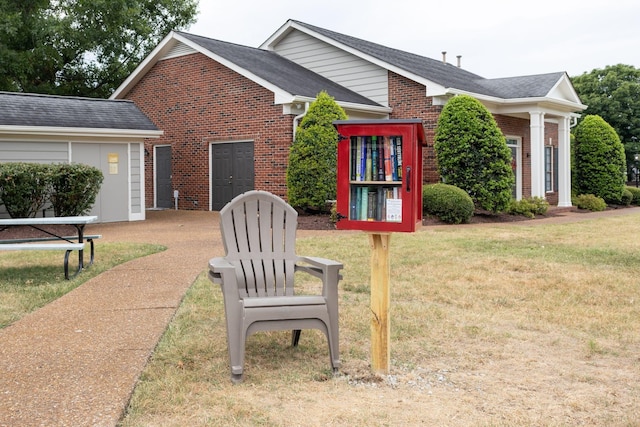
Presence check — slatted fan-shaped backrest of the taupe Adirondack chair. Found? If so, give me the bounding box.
[220,191,298,297]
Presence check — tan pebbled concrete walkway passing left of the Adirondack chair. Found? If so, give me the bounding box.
[0,208,640,427]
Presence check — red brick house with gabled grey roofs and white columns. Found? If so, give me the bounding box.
[112,20,586,210]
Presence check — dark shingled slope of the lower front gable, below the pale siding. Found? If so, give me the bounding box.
[176,32,380,106]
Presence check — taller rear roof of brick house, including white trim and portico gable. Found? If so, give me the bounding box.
[261,20,586,108]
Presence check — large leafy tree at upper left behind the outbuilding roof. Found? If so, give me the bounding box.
[0,0,198,97]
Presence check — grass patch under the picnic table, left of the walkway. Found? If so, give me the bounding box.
[0,242,166,328]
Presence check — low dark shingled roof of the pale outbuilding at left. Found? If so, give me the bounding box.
[0,92,158,131]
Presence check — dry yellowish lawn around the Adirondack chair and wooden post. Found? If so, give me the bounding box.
[121,215,640,427]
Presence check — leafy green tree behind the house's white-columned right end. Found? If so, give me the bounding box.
[571,64,640,174]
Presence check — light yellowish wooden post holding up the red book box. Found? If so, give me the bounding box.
[369,233,391,374]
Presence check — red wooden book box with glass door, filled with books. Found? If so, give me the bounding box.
[334,119,425,233]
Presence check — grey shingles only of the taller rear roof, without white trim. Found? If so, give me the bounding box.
[291,20,564,99]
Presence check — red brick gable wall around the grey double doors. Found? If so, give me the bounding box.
[126,53,293,210]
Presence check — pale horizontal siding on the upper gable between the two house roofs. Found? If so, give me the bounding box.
[275,30,389,106]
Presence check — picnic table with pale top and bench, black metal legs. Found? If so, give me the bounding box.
[0,215,101,279]
